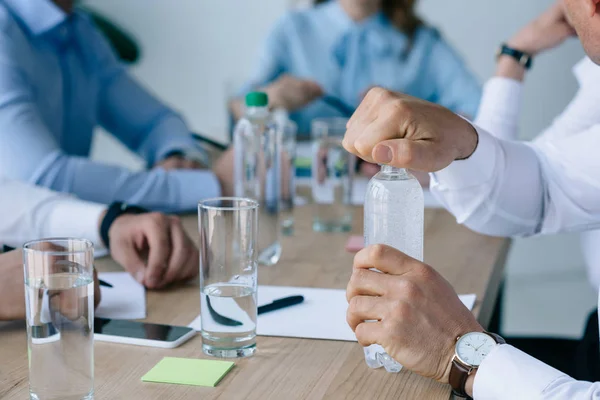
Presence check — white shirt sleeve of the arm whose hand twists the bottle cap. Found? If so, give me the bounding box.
[431,126,600,236]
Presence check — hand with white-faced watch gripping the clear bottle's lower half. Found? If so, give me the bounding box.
[346,245,483,383]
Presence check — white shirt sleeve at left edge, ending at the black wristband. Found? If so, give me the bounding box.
[0,177,106,250]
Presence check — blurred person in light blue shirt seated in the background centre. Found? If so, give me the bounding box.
[231,0,481,135]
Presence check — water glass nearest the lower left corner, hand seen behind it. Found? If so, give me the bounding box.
[23,239,94,400]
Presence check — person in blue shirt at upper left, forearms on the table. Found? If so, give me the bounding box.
[0,0,229,212]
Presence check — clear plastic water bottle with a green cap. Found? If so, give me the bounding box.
[233,92,282,266]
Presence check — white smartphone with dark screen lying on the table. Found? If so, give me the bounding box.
[94,318,196,349]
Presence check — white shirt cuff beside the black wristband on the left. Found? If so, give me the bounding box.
[44,198,106,250]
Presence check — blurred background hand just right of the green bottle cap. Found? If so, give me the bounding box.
[263,75,323,111]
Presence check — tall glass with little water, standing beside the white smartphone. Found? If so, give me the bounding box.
[198,198,258,357]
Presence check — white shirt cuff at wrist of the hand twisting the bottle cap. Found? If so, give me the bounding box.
[431,125,499,190]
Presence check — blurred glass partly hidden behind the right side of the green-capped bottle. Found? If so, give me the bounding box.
[280,120,298,236]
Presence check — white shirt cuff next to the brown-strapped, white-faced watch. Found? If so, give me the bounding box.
[473,345,566,399]
